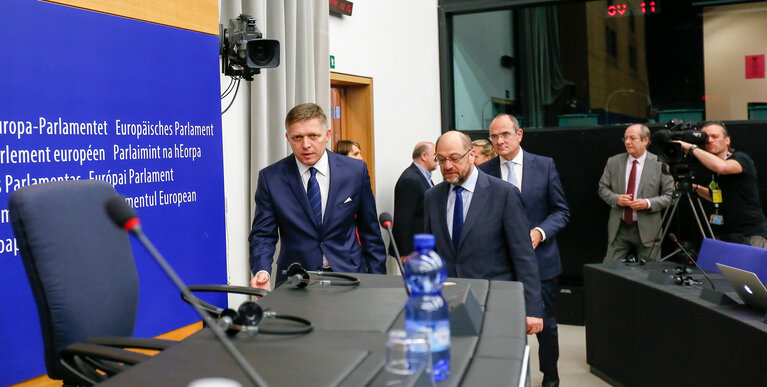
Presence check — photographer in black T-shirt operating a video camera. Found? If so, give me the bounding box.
[674,121,767,248]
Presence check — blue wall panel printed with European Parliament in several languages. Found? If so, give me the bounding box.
[0,0,226,385]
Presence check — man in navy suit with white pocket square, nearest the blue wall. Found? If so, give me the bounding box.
[248,103,386,289]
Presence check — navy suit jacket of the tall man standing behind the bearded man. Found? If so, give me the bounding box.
[479,150,570,279]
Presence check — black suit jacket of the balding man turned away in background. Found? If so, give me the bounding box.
[392,163,431,258]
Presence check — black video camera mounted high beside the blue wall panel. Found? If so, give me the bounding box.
[219,14,280,81]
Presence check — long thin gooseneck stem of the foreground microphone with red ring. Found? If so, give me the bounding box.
[129,224,268,386]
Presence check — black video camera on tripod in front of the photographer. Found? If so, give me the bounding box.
[652,118,708,192]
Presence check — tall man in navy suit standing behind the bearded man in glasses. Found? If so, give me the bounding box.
[479,114,570,386]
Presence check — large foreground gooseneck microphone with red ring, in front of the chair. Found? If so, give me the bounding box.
[106,194,267,386]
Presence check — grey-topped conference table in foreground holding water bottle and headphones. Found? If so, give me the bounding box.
[102,274,527,386]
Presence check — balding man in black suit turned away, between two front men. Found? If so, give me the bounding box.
[393,142,437,258]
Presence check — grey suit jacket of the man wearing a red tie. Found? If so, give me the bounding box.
[599,151,674,246]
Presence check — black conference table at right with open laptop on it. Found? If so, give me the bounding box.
[584,263,767,386]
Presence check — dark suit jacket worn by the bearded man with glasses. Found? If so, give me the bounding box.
[424,171,543,317]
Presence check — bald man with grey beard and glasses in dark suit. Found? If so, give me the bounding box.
[424,131,543,334]
